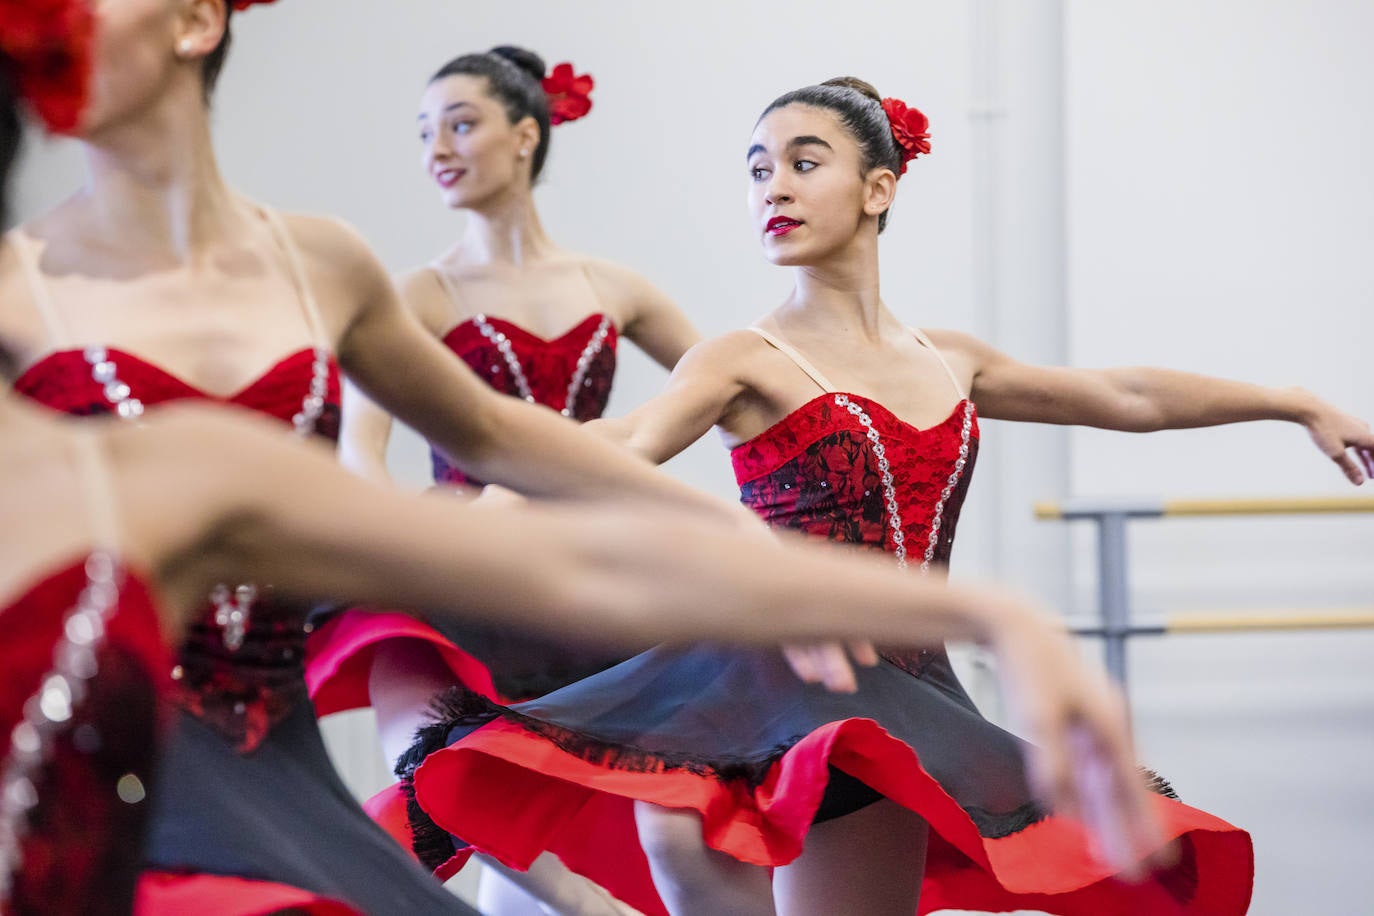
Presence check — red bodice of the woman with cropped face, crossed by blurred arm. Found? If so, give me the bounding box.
[14,349,339,751]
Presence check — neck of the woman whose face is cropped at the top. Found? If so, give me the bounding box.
[77,81,243,264]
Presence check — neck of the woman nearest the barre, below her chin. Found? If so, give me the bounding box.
[778,233,896,342]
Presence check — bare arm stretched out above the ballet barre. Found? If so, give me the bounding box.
[930,331,1374,485]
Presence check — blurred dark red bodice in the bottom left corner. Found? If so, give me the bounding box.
[0,558,172,913]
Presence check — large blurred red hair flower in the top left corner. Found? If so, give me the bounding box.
[0,0,95,133]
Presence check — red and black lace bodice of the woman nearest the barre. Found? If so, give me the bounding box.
[731,393,978,566]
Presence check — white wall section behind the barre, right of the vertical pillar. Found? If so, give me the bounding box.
[1066,0,1374,913]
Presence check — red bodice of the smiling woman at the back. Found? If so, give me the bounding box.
[430,313,618,486]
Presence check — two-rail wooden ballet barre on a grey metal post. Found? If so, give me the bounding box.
[1035,496,1374,685]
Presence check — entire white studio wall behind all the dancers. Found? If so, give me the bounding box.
[19,0,1374,913]
